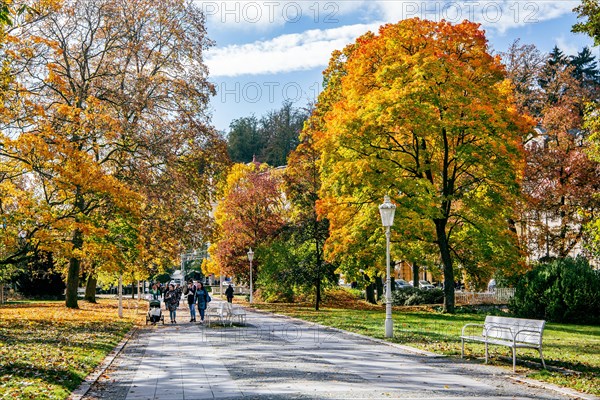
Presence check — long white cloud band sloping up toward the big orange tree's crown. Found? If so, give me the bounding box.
[206,22,381,77]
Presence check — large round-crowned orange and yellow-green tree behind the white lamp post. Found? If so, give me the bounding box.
[316,18,531,312]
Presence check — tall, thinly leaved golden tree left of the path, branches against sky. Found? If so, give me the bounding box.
[6,0,226,307]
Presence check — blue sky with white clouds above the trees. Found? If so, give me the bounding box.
[197,0,599,131]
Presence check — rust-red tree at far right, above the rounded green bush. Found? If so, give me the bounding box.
[523,59,600,258]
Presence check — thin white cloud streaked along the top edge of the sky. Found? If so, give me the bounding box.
[197,0,579,33]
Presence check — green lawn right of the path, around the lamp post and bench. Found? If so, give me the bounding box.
[255,304,600,395]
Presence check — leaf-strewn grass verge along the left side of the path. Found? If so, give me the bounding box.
[0,299,146,399]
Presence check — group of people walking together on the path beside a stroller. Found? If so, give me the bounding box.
[150,281,211,324]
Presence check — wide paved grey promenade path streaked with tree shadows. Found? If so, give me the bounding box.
[79,299,584,400]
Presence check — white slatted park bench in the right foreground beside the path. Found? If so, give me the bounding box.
[460,315,546,372]
